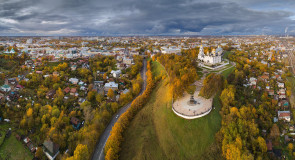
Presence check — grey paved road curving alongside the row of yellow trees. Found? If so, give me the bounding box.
[92,59,147,160]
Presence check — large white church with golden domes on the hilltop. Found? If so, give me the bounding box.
[198,45,223,65]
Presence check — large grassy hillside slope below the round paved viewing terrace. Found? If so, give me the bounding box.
[120,60,221,160]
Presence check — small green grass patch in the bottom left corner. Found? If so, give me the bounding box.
[0,124,34,160]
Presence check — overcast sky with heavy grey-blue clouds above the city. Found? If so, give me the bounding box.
[0,0,295,36]
